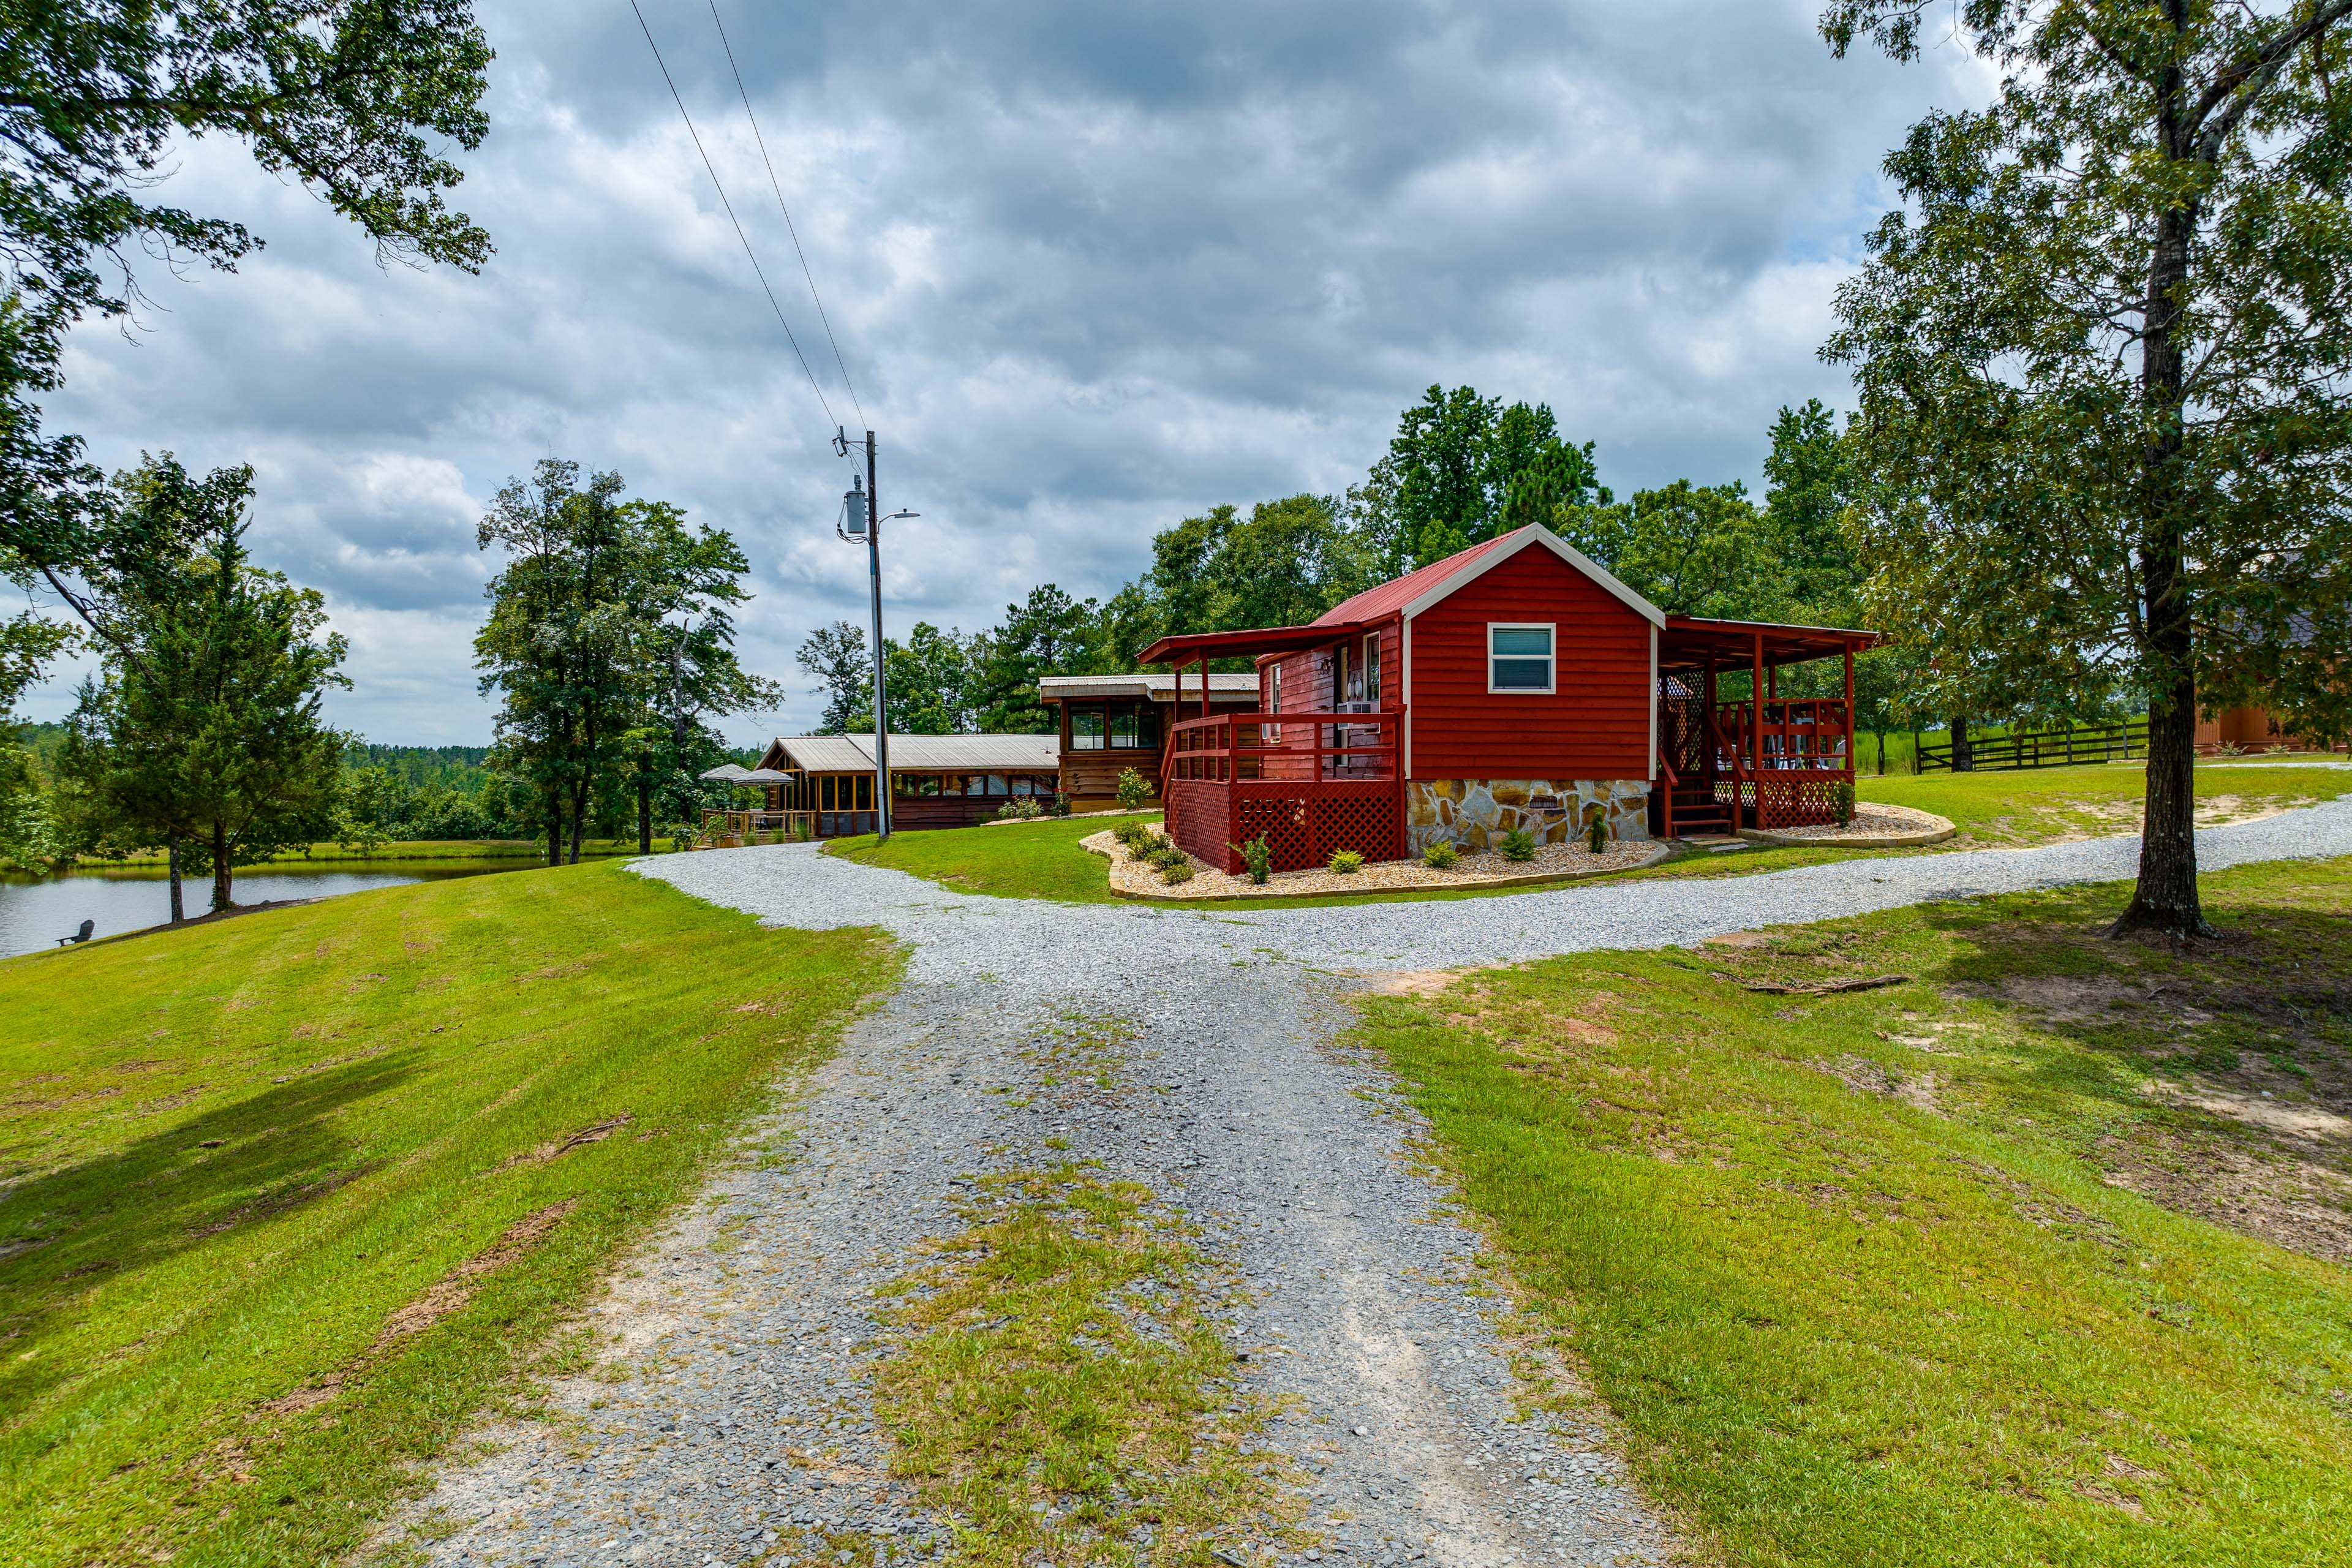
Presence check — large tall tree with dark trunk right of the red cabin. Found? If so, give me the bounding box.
[1820,0,2352,936]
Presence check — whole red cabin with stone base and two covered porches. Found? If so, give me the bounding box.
[1140,527,1877,872]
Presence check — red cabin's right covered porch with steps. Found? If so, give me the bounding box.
[1649,616,1879,839]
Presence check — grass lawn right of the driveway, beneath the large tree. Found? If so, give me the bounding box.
[1362,861,2352,1568]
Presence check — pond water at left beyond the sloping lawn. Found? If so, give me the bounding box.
[0,858,538,957]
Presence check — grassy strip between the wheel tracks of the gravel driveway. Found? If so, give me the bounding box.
[880,1166,1303,1568]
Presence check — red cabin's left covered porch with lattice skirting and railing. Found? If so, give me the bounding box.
[1140,620,1404,875]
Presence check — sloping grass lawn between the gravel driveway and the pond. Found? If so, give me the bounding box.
[0,865,896,1568]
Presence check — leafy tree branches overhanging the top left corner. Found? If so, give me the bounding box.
[0,0,492,649]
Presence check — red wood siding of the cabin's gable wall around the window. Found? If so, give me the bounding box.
[1383,545,1651,778]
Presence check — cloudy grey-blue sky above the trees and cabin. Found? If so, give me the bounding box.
[28,0,1985,743]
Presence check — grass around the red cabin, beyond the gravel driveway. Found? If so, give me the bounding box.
[826,762,2352,910]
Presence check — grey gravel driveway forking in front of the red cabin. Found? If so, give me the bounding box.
[385,802,2352,1568]
